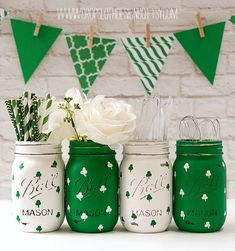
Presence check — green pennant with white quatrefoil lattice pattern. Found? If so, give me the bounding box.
[66,35,116,94]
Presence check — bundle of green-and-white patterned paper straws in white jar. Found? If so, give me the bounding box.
[5,92,53,141]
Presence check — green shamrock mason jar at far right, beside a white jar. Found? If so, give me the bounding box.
[173,140,226,233]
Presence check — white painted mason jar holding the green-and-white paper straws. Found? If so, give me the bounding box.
[12,142,64,233]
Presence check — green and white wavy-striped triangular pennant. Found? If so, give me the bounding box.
[121,36,174,95]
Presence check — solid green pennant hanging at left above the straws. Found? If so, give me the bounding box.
[11,19,62,83]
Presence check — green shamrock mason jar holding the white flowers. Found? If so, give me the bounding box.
[66,141,118,233]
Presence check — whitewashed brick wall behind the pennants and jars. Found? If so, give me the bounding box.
[0,0,235,199]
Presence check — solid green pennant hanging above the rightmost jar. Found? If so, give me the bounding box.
[174,22,225,85]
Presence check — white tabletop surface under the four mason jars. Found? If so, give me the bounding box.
[0,200,235,251]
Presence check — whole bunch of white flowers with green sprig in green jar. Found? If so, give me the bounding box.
[44,88,136,148]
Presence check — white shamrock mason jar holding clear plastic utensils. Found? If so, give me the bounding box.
[120,142,172,233]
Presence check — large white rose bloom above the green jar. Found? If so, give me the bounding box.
[75,95,136,148]
